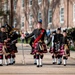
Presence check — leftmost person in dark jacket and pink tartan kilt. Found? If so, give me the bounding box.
[0,26,9,66]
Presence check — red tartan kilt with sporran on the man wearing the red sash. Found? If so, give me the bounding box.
[33,42,47,54]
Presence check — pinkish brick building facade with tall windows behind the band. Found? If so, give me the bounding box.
[3,0,75,31]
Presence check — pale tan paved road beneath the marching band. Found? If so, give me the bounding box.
[0,45,75,75]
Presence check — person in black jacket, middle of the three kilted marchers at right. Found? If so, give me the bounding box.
[53,28,63,65]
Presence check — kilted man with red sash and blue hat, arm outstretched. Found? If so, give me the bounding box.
[26,20,47,67]
